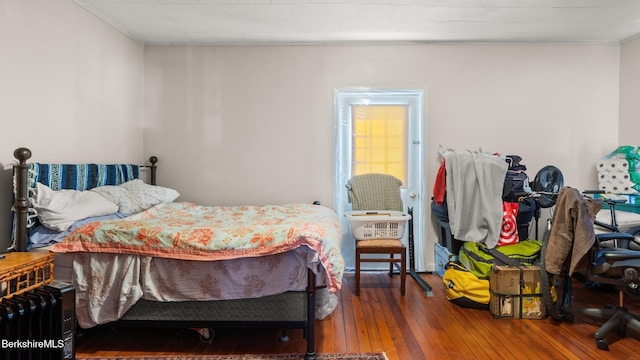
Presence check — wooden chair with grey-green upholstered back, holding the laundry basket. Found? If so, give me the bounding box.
[346,174,407,296]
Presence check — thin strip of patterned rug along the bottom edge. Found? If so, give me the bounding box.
[76,353,387,360]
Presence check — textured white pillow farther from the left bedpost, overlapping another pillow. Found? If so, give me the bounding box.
[91,179,180,214]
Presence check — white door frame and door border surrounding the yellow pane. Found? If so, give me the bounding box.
[333,88,427,271]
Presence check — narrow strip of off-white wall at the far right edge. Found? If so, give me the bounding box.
[619,38,640,145]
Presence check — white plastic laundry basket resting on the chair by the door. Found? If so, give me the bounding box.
[345,210,411,240]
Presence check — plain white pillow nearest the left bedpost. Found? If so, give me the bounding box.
[33,183,118,231]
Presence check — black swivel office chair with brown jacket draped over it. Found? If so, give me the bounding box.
[541,187,640,350]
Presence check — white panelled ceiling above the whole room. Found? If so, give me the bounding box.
[74,0,640,44]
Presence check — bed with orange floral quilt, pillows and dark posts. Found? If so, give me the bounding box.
[9,148,344,359]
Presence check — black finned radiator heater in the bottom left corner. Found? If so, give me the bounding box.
[0,281,76,360]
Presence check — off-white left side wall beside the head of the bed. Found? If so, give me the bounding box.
[0,0,143,249]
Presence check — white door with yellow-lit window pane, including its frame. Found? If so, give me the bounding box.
[333,88,425,271]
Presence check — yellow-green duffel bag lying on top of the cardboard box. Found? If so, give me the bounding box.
[458,240,542,279]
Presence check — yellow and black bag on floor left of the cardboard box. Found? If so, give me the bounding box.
[442,261,491,310]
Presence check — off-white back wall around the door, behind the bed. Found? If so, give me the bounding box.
[144,44,619,270]
